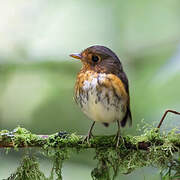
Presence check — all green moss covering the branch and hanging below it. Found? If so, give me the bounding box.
[0,127,180,180]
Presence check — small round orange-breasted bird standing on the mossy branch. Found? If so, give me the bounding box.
[70,45,132,146]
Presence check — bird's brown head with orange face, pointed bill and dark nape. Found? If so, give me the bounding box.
[70,45,129,93]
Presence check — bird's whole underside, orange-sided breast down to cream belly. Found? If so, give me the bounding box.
[75,71,128,123]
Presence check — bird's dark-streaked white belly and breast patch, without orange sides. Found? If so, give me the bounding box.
[77,74,126,123]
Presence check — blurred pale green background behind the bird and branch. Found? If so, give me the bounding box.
[0,0,180,180]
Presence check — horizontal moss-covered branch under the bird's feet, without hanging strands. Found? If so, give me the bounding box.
[0,127,180,150]
